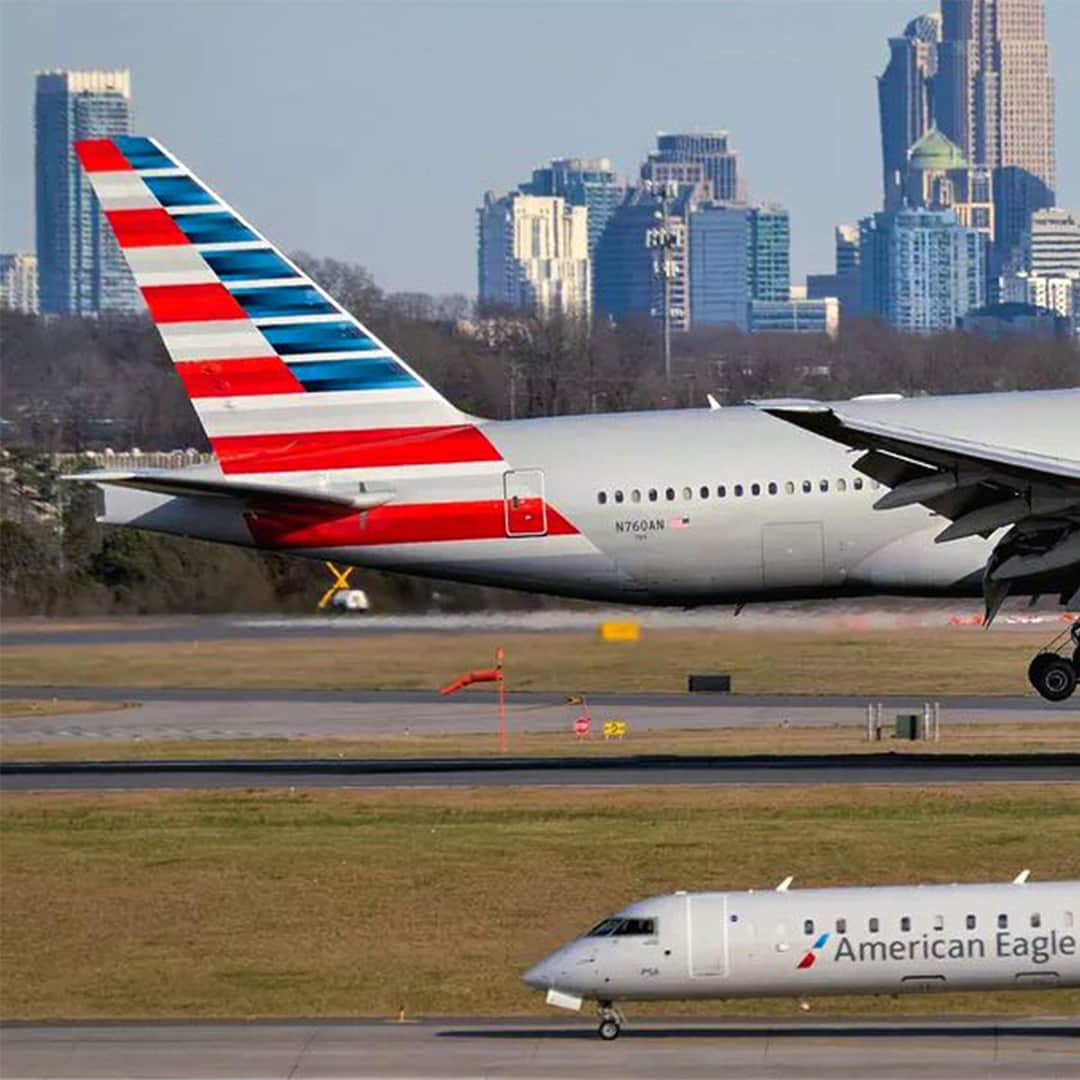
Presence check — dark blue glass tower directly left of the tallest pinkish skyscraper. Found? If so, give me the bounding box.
[878,12,942,210]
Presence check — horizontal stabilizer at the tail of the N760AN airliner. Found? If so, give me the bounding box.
[62,469,393,510]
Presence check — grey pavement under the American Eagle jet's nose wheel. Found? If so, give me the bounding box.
[0,1018,1080,1080]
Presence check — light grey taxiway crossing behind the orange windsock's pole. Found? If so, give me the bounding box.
[0,686,1080,742]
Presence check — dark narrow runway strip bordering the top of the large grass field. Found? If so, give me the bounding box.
[0,754,1080,792]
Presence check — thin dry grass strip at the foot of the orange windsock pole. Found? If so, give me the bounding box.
[8,720,1080,761]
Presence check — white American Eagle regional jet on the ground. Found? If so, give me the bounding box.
[522,870,1080,1039]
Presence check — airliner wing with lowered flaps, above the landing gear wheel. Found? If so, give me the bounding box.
[755,401,1080,620]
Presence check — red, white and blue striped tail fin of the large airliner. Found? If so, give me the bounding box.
[76,136,498,474]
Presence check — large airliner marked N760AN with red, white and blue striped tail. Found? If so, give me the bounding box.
[77,136,1080,700]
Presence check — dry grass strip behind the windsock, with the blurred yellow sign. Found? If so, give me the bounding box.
[3,627,1049,694]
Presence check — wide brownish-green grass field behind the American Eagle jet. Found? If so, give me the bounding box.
[0,785,1080,1018]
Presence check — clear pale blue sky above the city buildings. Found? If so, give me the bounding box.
[0,0,1080,294]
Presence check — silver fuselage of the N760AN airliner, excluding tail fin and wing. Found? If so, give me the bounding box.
[95,391,1080,606]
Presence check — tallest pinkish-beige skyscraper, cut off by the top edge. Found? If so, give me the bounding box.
[934,0,1055,265]
